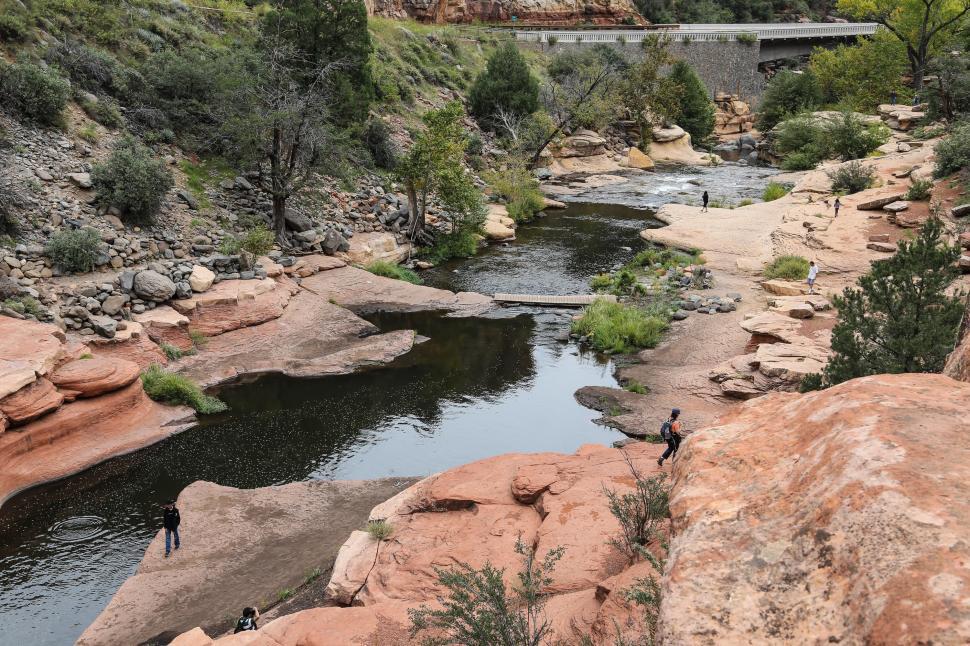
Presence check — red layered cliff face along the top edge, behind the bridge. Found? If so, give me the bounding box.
[366,0,644,25]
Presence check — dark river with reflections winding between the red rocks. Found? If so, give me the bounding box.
[0,165,776,646]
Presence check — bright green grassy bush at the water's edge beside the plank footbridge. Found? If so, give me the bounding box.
[572,299,669,353]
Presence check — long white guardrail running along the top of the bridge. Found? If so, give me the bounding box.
[515,22,879,44]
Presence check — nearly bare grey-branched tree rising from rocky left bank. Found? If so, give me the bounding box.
[218,40,342,243]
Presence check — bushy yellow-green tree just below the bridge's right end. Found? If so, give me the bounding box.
[810,30,908,112]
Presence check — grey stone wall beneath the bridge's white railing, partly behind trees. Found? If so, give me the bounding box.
[518,41,764,106]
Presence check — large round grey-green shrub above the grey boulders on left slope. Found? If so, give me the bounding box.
[91,136,174,221]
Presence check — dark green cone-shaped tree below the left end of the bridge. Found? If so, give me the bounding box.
[468,42,539,127]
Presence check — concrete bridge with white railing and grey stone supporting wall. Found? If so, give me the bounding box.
[513,22,879,103]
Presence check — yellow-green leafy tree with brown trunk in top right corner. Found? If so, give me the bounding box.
[836,0,970,92]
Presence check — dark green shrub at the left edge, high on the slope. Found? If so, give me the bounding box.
[0,61,71,125]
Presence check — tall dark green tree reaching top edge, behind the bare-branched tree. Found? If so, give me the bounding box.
[263,0,374,125]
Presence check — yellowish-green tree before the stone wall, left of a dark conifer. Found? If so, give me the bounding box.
[618,36,684,142]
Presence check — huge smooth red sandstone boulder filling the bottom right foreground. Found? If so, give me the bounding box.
[660,375,970,644]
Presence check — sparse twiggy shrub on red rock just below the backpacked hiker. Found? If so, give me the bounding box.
[603,452,670,560]
